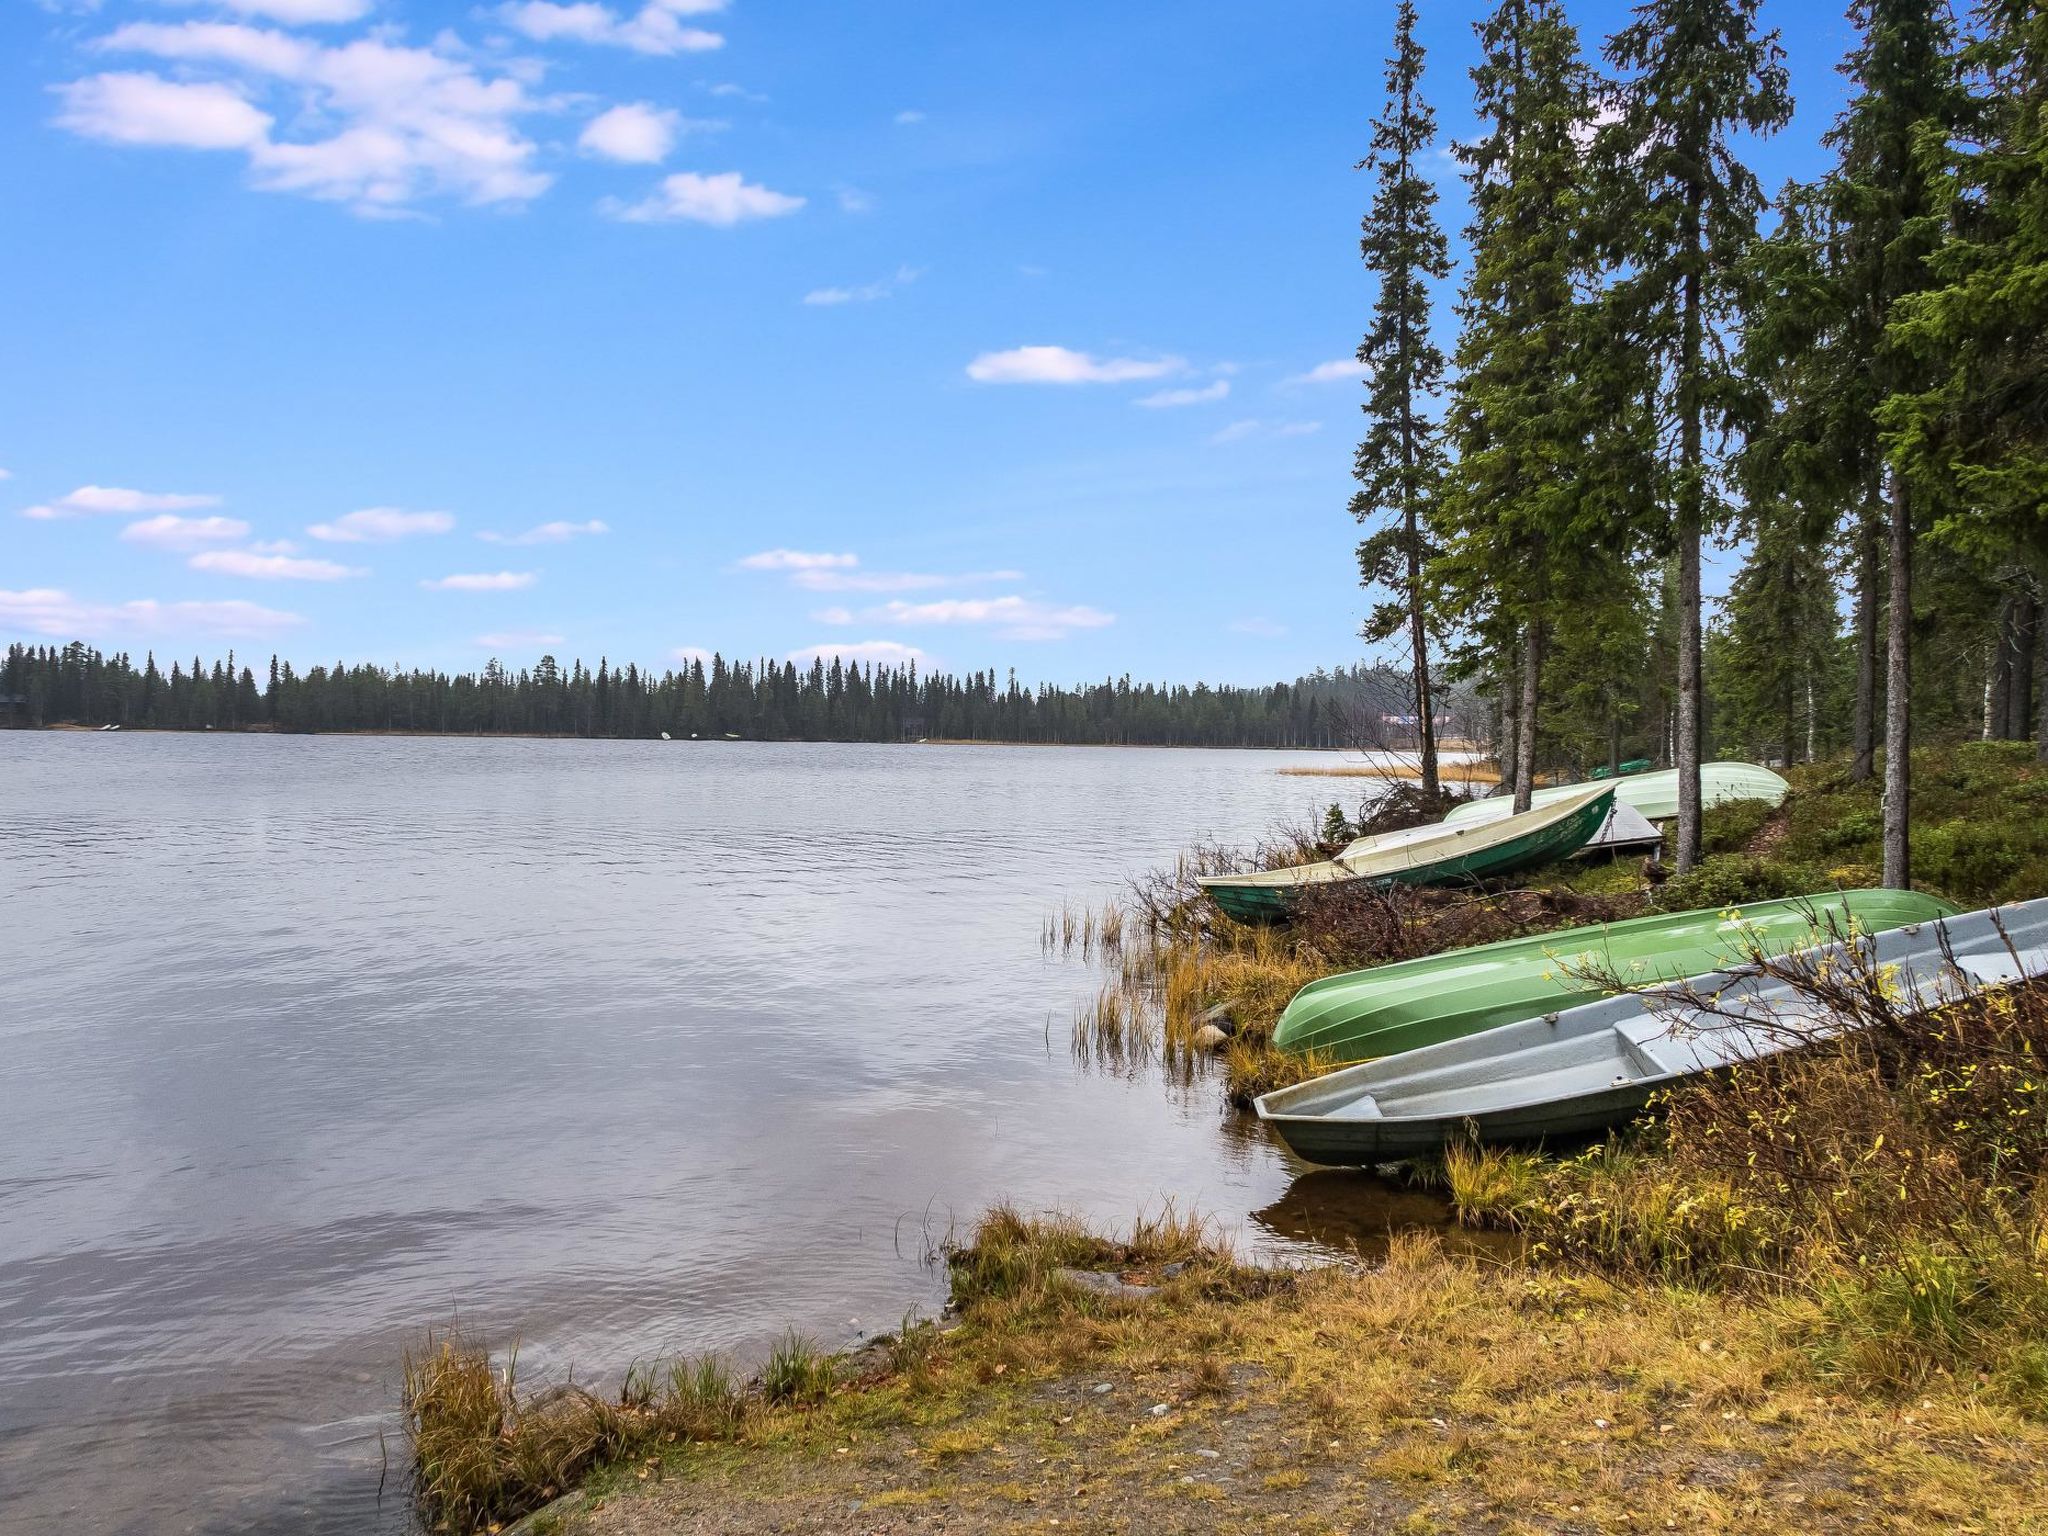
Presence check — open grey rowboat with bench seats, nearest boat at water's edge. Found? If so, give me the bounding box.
[1257,899,2048,1165]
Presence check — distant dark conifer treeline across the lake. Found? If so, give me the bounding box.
[0,643,1490,748]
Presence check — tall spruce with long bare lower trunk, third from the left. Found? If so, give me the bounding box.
[1602,0,1792,872]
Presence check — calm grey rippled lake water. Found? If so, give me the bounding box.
[0,733,1458,1532]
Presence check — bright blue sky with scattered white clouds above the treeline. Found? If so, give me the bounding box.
[0,0,1851,682]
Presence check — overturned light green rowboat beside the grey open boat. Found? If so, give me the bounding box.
[1274,891,1956,1061]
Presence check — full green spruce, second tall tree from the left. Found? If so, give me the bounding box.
[1432,0,1597,811]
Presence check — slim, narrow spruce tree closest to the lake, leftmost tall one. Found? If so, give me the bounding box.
[1352,0,1450,801]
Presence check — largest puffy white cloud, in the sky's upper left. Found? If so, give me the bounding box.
[81,20,553,215]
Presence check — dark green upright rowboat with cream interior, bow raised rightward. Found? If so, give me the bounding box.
[1200,784,1614,924]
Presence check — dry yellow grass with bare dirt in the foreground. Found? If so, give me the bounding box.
[552,1214,2048,1536]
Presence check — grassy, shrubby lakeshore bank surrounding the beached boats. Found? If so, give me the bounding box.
[408,743,2048,1536]
